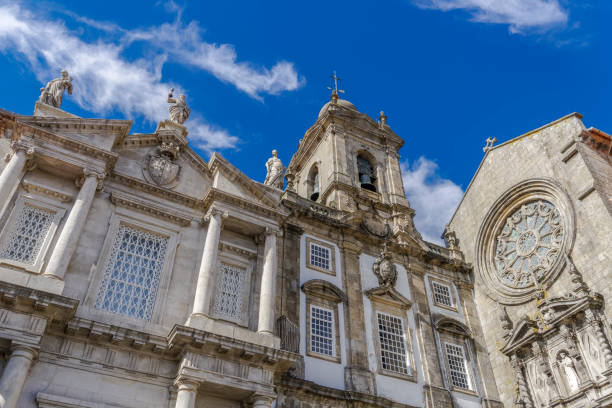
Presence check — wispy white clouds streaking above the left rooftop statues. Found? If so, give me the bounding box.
[0,2,303,151]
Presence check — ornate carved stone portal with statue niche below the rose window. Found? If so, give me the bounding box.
[501,293,612,407]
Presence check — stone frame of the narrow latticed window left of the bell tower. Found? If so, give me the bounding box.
[209,252,253,327]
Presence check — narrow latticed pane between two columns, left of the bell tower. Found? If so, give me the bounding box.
[215,263,246,319]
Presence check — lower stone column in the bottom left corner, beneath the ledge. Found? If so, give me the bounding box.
[0,345,37,408]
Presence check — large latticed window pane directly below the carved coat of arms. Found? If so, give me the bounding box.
[96,225,168,320]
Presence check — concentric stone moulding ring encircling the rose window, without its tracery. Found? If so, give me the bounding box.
[475,178,576,305]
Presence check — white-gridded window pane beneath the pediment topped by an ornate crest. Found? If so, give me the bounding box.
[378,313,410,374]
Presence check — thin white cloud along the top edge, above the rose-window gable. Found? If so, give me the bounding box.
[412,0,568,33]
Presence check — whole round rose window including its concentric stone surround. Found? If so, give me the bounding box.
[475,179,574,304]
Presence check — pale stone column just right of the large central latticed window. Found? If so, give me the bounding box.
[191,208,223,316]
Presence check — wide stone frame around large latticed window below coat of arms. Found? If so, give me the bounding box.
[83,207,180,329]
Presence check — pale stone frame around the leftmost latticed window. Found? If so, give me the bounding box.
[0,193,67,273]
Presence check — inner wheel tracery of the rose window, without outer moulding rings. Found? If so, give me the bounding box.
[495,200,564,288]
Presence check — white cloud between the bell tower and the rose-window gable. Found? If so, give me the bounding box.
[402,157,463,244]
